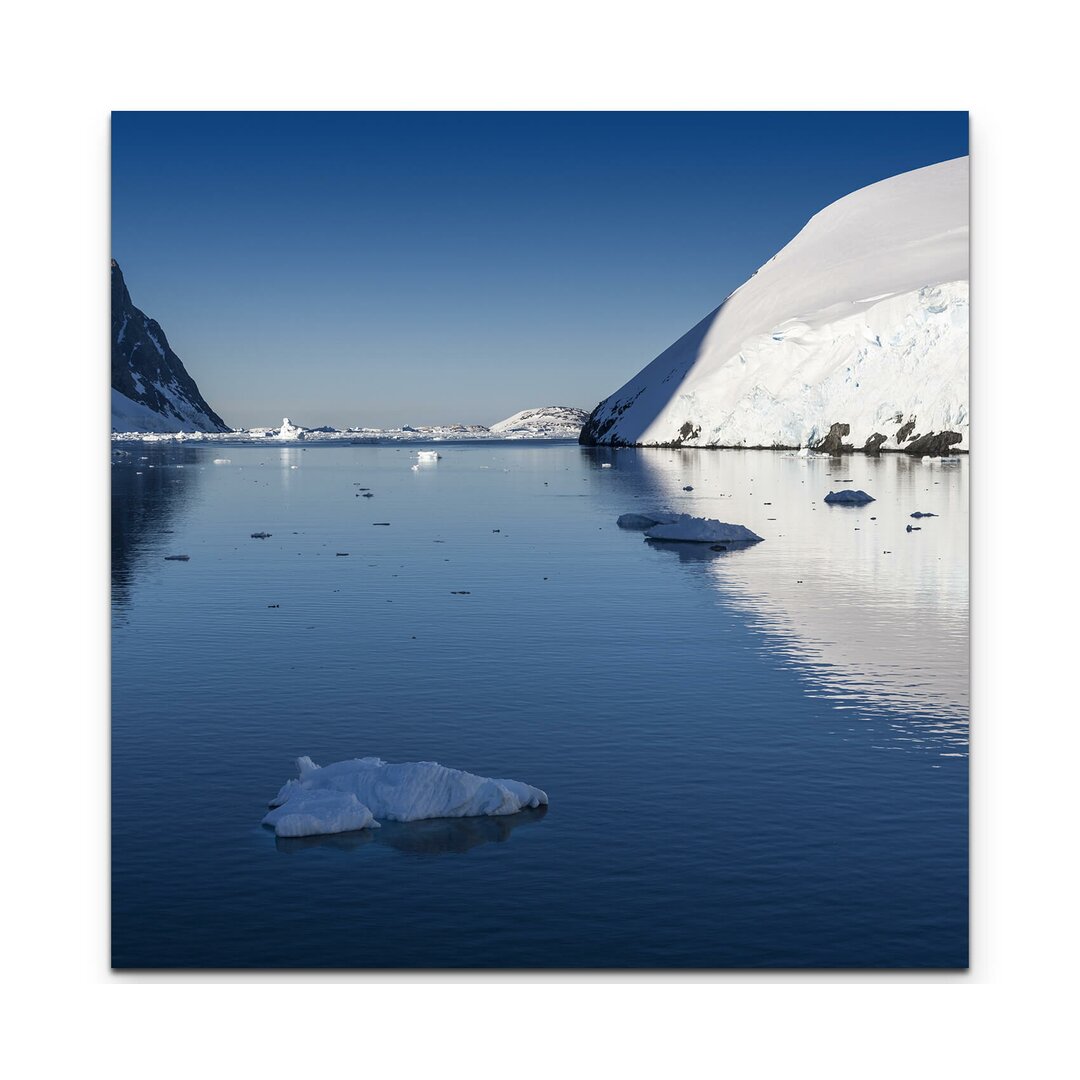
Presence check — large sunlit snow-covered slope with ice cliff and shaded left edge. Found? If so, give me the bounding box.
[581,158,968,454]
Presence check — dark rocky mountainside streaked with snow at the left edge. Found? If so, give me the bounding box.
[112,260,229,432]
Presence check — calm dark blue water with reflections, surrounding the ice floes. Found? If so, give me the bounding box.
[112,444,968,968]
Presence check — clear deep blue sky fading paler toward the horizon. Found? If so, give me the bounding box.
[112,112,968,427]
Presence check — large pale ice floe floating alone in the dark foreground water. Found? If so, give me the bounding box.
[262,757,548,836]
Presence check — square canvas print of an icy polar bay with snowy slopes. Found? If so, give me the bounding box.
[113,112,971,970]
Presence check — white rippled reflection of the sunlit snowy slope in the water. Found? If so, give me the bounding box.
[591,449,969,752]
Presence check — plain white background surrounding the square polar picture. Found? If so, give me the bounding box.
[0,0,1080,1078]
